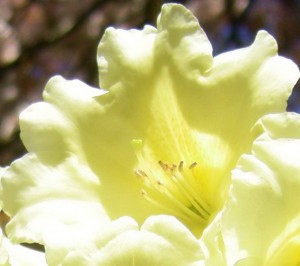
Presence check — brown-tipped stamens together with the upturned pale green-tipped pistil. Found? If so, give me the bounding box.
[133,137,225,235]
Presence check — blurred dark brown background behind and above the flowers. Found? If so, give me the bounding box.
[0,0,300,166]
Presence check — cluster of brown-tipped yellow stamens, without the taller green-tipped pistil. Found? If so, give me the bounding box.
[135,152,211,227]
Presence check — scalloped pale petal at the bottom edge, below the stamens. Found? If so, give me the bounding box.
[48,215,203,266]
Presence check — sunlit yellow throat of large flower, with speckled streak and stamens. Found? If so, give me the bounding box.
[132,67,232,234]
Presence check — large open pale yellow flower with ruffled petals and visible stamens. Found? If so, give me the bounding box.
[2,4,299,265]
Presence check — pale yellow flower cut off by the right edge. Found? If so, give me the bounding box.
[203,113,300,266]
